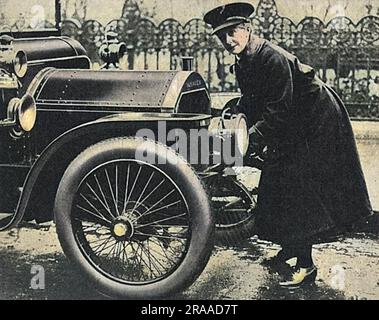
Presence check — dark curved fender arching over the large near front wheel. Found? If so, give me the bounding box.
[10,113,210,228]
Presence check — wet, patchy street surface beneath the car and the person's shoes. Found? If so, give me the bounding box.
[0,227,379,300]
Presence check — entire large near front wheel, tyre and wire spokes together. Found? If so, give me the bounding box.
[55,138,214,299]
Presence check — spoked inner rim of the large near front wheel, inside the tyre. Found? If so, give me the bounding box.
[73,159,190,284]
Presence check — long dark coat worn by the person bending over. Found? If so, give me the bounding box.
[235,36,372,245]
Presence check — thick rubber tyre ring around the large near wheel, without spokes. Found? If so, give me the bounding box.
[54,138,214,299]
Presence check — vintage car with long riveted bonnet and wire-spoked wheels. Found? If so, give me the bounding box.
[0,1,255,299]
